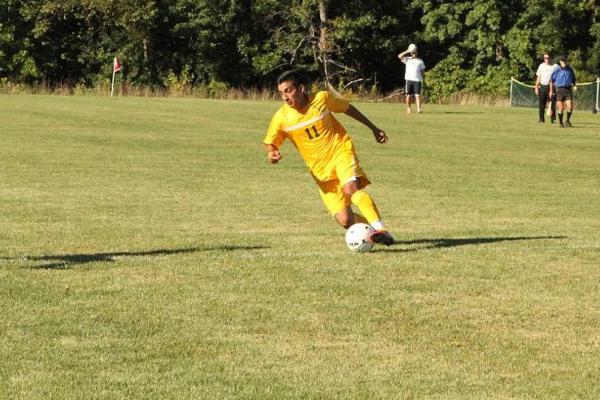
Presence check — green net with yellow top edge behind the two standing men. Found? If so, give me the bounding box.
[510,78,600,113]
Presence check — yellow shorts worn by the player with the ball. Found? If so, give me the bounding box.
[316,151,371,215]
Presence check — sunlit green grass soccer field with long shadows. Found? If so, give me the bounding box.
[0,96,600,399]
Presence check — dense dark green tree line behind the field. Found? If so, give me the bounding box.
[0,0,600,97]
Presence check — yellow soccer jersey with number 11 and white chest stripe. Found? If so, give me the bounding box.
[263,91,354,181]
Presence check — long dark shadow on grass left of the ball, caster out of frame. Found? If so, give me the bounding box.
[2,244,267,269]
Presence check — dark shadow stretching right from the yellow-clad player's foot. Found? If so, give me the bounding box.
[381,236,567,253]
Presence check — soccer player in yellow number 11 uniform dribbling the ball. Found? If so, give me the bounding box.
[263,70,394,246]
